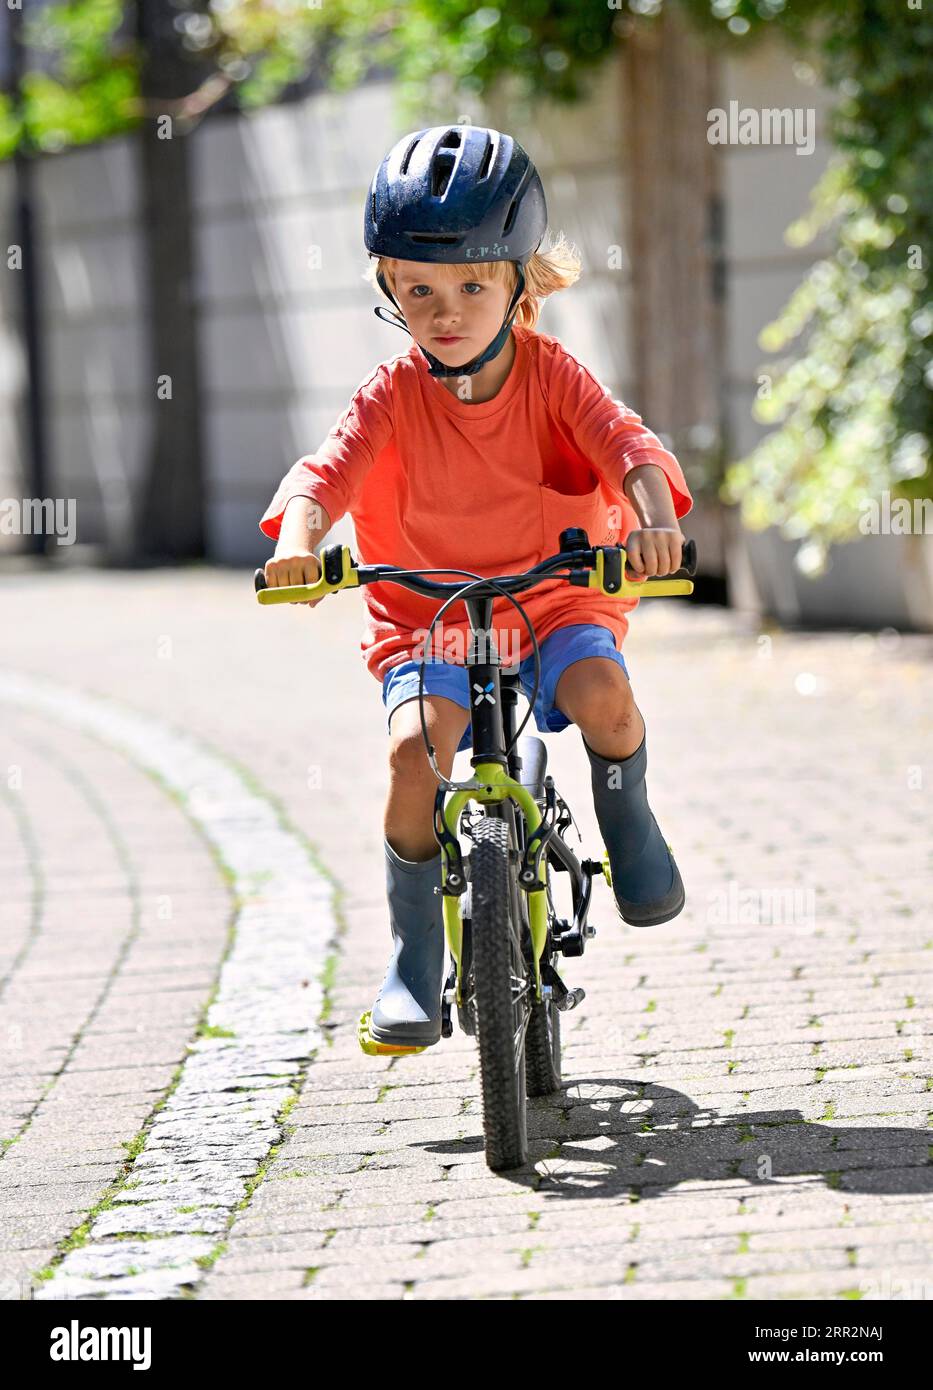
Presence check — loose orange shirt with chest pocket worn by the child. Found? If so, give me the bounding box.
[259,319,692,681]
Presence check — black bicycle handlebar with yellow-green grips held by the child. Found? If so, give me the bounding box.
[254,527,697,605]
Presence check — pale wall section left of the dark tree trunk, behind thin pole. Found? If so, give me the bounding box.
[0,140,153,543]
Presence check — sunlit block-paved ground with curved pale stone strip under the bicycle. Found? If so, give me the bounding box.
[0,567,933,1301]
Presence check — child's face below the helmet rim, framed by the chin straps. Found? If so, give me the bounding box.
[386,260,512,367]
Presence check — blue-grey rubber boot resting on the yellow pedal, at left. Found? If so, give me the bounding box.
[370,840,446,1047]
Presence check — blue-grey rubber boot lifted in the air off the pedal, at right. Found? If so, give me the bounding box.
[581,735,685,927]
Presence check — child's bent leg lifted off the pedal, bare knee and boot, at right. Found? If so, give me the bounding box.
[555,628,685,927]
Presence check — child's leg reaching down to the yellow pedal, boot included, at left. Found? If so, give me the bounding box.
[370,673,470,1047]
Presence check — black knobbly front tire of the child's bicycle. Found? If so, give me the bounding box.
[470,816,531,1173]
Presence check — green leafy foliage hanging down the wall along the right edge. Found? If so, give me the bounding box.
[691,0,933,553]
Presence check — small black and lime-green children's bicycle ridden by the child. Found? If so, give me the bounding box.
[256,527,697,1172]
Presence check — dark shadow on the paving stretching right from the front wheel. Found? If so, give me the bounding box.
[427,1077,933,1200]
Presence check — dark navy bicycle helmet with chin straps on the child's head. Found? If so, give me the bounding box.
[363,125,548,377]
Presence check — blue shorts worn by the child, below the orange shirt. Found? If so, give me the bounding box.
[382,623,631,753]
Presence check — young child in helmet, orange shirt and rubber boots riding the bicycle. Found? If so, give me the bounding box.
[260,125,692,1047]
